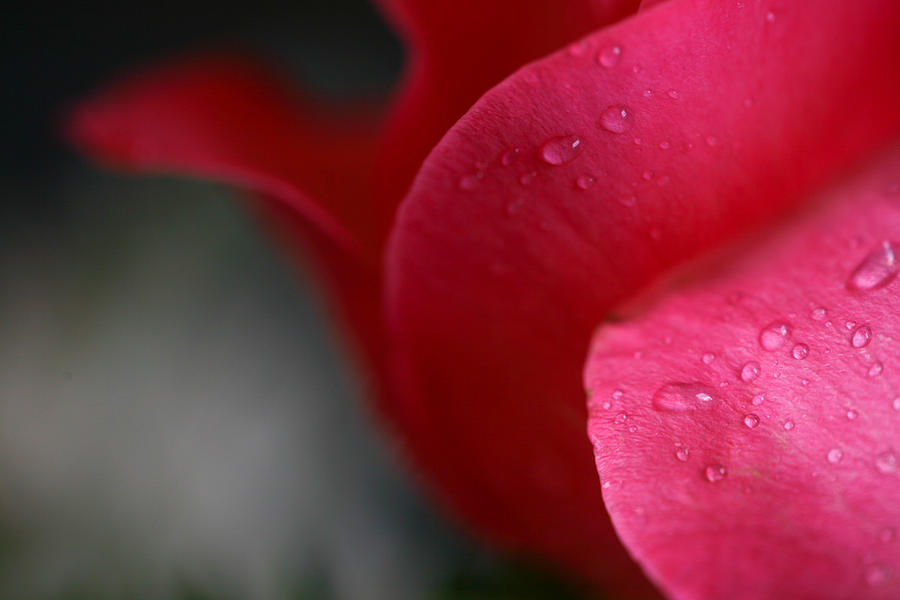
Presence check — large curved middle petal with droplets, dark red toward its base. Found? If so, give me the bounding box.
[387,0,900,592]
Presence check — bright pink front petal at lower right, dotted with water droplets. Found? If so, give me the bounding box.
[585,149,900,600]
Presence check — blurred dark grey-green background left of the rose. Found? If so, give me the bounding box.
[0,0,604,600]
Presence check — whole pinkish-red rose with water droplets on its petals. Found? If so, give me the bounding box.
[72,0,900,598]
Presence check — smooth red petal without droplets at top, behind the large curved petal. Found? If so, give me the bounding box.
[370,0,639,205]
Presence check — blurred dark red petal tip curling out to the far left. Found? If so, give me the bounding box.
[69,56,383,251]
